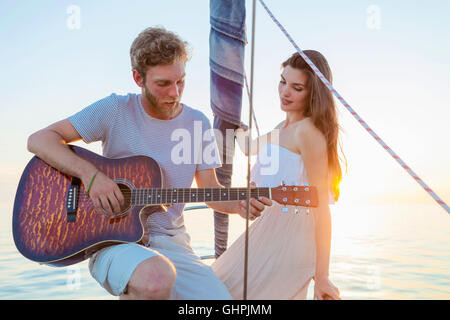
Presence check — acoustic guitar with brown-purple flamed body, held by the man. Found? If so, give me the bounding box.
[12,146,318,266]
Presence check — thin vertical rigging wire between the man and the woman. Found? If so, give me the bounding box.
[243,0,256,300]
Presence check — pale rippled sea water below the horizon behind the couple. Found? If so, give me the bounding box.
[0,204,450,300]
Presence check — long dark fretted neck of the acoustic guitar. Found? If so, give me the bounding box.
[131,188,271,205]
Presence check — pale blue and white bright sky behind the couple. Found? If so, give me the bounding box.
[0,0,450,218]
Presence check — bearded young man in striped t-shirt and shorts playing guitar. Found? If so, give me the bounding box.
[28,28,271,299]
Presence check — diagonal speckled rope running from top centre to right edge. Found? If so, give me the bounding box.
[259,0,450,214]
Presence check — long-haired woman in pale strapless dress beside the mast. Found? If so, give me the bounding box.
[212,50,342,300]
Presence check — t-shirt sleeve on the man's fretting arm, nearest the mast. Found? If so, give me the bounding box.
[196,114,222,171]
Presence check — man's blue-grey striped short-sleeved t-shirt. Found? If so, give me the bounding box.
[69,93,221,235]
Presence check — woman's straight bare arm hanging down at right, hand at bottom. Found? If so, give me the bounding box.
[295,121,339,299]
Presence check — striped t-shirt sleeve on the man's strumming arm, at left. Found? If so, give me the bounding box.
[69,93,118,143]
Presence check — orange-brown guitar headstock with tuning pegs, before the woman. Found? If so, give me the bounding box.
[271,184,319,207]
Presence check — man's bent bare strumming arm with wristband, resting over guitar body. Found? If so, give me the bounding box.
[28,119,124,215]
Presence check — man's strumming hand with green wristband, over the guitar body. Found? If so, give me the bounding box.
[82,171,125,218]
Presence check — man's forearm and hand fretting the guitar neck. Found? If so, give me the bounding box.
[195,169,272,218]
